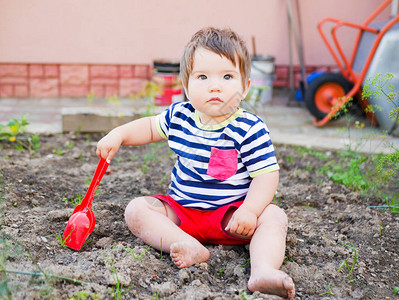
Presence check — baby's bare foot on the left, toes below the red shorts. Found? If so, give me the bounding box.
[170,241,209,269]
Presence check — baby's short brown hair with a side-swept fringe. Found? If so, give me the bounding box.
[180,27,251,90]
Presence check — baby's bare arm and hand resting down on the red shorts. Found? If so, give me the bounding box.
[225,171,279,238]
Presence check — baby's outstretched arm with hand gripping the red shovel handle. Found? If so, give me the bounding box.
[96,116,162,163]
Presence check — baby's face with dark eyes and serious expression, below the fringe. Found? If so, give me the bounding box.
[185,48,250,125]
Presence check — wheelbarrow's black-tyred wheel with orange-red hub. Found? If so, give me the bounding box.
[305,73,353,120]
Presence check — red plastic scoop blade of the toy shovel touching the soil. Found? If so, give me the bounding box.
[62,210,96,250]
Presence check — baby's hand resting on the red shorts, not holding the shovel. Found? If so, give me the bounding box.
[225,205,258,239]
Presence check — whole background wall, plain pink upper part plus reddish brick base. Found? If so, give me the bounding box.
[0,0,390,98]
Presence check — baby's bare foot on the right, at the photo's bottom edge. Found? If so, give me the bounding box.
[248,269,295,299]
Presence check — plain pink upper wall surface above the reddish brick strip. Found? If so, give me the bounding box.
[0,0,389,65]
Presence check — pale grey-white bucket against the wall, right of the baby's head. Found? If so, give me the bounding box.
[250,56,275,104]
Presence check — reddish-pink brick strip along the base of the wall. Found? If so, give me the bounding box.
[0,63,335,98]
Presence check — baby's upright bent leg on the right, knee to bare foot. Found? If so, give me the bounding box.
[248,205,295,299]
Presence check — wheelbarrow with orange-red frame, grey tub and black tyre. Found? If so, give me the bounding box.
[304,0,399,132]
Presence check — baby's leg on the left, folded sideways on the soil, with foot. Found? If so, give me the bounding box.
[125,197,209,268]
